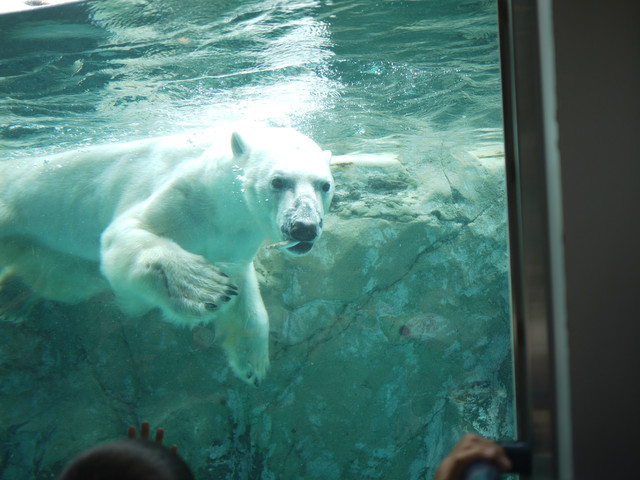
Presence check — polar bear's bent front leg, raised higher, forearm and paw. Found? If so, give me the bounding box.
[101,218,238,325]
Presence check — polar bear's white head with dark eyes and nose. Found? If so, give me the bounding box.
[231,128,334,255]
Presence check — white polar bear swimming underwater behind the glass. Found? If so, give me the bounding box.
[0,127,334,384]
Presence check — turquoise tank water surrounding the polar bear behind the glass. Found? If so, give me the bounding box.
[0,0,515,479]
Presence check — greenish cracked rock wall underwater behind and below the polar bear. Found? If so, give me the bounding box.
[0,144,515,480]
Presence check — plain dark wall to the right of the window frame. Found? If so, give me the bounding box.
[553,0,640,480]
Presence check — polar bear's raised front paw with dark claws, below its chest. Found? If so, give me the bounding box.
[144,255,238,319]
